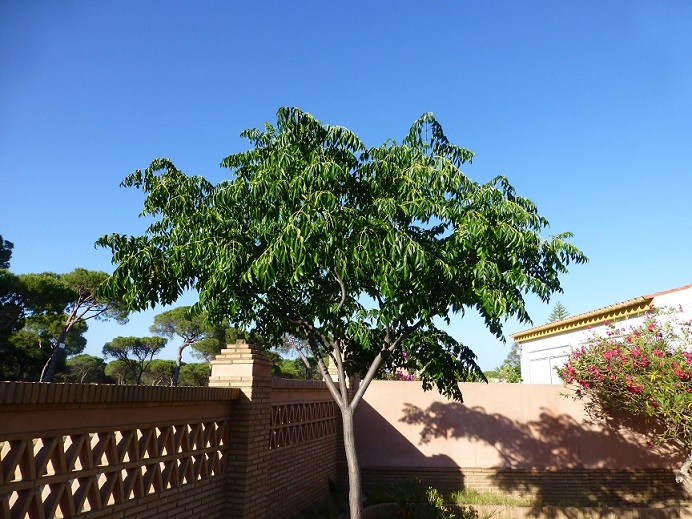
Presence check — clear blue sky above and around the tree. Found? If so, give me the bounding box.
[0,0,692,369]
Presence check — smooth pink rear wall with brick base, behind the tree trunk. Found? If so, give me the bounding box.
[356,381,687,502]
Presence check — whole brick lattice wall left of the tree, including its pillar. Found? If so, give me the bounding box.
[0,341,338,519]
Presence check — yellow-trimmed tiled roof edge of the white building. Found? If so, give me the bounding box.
[510,285,692,343]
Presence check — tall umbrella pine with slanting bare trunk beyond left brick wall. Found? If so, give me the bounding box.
[41,268,128,382]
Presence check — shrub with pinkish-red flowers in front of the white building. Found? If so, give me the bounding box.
[558,309,692,491]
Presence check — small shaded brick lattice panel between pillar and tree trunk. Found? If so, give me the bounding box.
[269,402,336,449]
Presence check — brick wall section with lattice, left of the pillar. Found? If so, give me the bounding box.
[0,382,239,519]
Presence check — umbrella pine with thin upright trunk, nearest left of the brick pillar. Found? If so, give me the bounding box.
[149,306,223,386]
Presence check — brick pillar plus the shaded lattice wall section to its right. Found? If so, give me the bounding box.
[210,341,338,519]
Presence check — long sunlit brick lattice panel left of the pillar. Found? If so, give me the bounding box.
[0,420,229,519]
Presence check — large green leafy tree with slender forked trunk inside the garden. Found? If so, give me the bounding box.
[98,108,585,518]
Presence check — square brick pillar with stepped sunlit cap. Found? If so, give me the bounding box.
[209,340,272,519]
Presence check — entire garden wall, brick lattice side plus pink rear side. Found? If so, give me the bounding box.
[0,341,690,519]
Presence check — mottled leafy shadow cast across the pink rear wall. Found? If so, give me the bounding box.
[400,402,689,514]
